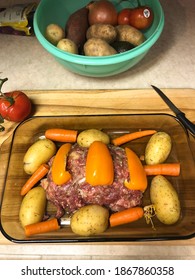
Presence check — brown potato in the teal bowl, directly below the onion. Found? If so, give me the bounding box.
[86,23,117,44]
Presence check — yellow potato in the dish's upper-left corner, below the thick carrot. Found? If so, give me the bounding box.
[23,139,56,175]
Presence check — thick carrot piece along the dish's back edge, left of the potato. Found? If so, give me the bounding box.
[45,128,78,143]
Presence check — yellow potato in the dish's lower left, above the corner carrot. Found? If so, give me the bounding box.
[19,186,46,227]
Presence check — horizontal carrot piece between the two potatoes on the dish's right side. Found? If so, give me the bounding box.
[144,162,180,176]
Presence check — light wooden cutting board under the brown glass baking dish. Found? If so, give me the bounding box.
[0,89,195,246]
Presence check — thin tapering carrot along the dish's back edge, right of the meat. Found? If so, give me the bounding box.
[112,130,157,146]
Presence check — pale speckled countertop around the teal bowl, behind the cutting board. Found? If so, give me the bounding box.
[0,0,195,91]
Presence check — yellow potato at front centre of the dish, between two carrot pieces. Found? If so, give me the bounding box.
[70,204,109,236]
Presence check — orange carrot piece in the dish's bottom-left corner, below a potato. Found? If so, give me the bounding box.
[24,218,60,236]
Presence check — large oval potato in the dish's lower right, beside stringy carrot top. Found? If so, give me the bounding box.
[150,175,181,225]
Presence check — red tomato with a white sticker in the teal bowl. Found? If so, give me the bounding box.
[129,6,154,29]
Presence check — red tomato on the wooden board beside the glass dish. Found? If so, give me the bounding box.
[0,79,31,122]
